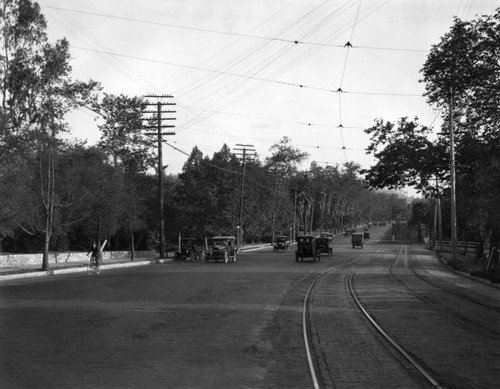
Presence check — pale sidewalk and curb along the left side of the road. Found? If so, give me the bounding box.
[0,244,271,282]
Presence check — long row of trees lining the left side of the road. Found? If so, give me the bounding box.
[0,0,404,269]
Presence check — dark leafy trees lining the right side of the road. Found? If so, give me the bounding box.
[363,8,500,255]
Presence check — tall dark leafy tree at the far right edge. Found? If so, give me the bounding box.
[422,8,500,252]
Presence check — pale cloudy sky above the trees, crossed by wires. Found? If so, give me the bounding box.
[39,0,499,183]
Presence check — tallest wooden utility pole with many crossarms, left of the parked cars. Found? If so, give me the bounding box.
[143,95,176,259]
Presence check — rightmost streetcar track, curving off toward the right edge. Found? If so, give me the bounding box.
[389,246,500,335]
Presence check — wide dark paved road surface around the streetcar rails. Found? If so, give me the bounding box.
[0,226,499,388]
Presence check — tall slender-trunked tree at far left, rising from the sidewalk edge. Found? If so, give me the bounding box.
[0,0,98,270]
